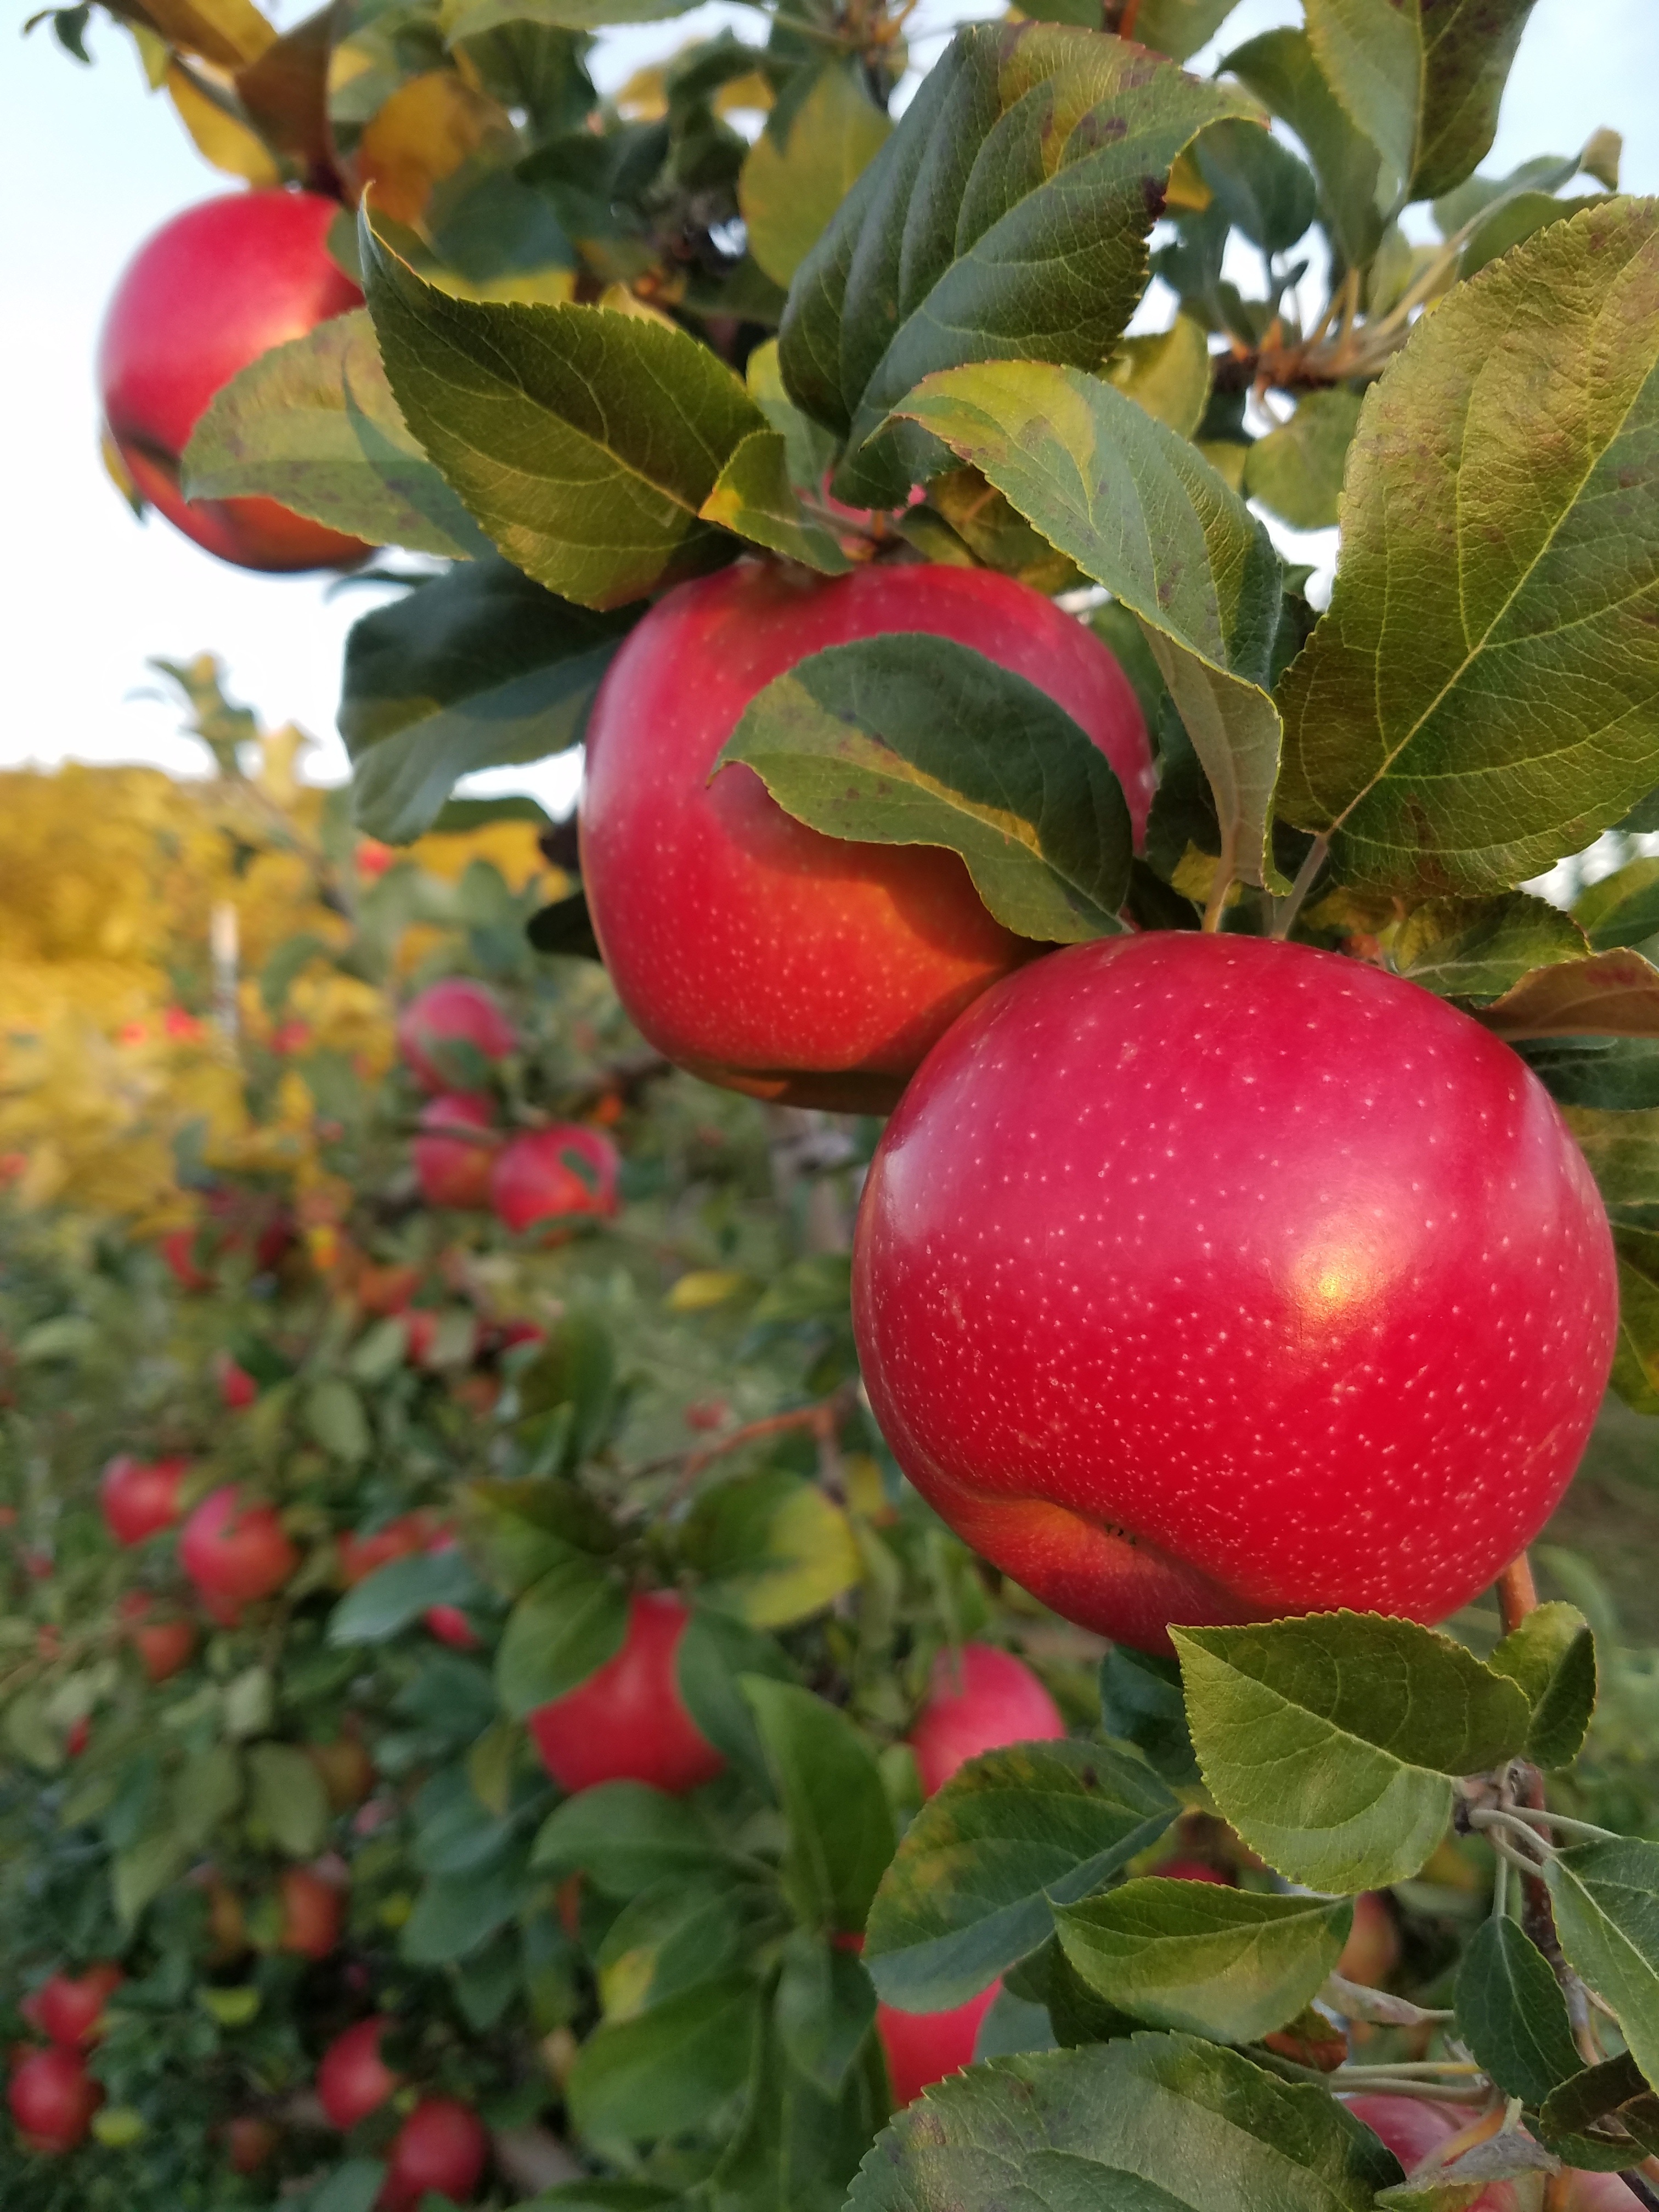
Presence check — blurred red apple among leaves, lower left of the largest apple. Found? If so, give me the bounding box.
[529,1590,725,1792]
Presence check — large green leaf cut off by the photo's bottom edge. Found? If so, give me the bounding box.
[847,2035,1400,2212]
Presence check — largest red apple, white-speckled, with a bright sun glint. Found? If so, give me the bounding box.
[854,931,1617,1650]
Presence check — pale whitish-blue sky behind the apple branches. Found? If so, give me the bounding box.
[0,0,1659,803]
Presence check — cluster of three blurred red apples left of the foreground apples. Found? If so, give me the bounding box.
[398,975,622,1243]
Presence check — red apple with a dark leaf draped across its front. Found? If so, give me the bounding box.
[582,560,1155,1113]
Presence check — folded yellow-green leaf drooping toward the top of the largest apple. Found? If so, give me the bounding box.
[905,360,1281,883]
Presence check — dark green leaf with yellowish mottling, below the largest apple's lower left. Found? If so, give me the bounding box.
[865,1743,1179,2013]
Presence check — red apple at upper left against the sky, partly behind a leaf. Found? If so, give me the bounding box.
[97,193,367,571]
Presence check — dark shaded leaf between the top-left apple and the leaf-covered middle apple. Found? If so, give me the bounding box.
[338,553,633,845]
